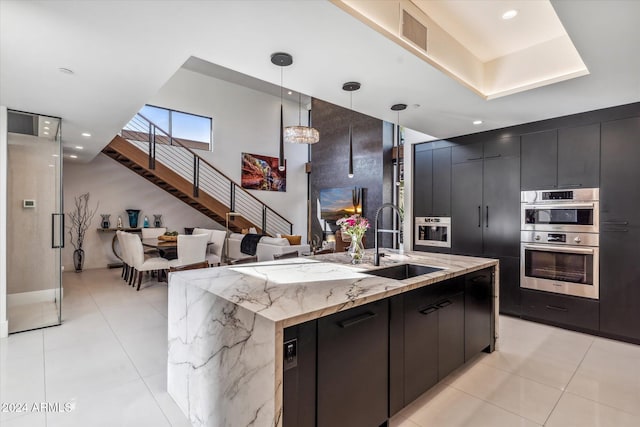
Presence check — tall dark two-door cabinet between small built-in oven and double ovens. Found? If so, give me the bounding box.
[451,136,521,315]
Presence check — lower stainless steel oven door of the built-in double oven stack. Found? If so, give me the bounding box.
[520,243,600,299]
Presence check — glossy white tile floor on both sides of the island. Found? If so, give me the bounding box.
[0,269,640,427]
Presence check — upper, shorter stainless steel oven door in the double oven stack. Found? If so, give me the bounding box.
[521,202,600,233]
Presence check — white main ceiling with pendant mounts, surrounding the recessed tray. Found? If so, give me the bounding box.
[0,0,640,161]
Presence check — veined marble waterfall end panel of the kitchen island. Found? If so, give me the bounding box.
[167,277,281,427]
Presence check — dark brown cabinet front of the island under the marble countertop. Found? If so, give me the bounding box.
[283,268,495,427]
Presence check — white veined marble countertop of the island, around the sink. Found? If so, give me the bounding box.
[170,249,498,328]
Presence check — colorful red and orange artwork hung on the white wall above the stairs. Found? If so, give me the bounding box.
[240,153,287,191]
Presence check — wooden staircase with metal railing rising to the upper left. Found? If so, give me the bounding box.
[102,114,293,235]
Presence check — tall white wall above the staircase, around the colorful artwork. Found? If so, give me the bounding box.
[147,69,310,241]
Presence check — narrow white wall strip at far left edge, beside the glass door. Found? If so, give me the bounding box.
[0,106,9,338]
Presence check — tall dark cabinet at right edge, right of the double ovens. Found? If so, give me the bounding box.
[600,117,640,341]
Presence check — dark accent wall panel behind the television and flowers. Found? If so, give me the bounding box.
[309,95,393,248]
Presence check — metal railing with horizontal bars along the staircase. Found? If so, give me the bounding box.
[121,113,293,235]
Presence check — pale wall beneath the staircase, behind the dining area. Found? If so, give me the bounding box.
[62,154,224,271]
